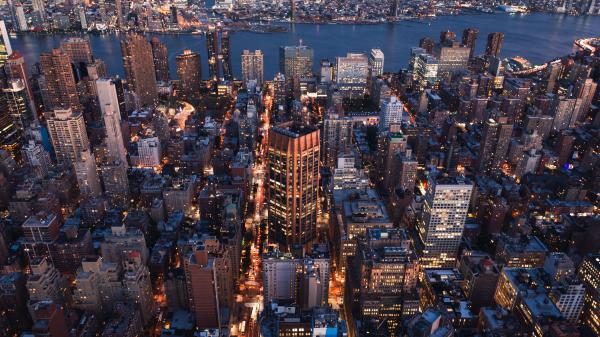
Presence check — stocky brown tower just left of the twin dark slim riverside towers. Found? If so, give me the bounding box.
[175,49,202,98]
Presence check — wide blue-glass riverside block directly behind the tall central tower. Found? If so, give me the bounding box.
[279,44,314,81]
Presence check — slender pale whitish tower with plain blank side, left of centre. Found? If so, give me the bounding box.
[96,78,127,165]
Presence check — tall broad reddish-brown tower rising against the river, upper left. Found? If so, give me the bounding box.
[121,33,158,106]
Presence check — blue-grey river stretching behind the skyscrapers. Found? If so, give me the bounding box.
[11,14,600,78]
